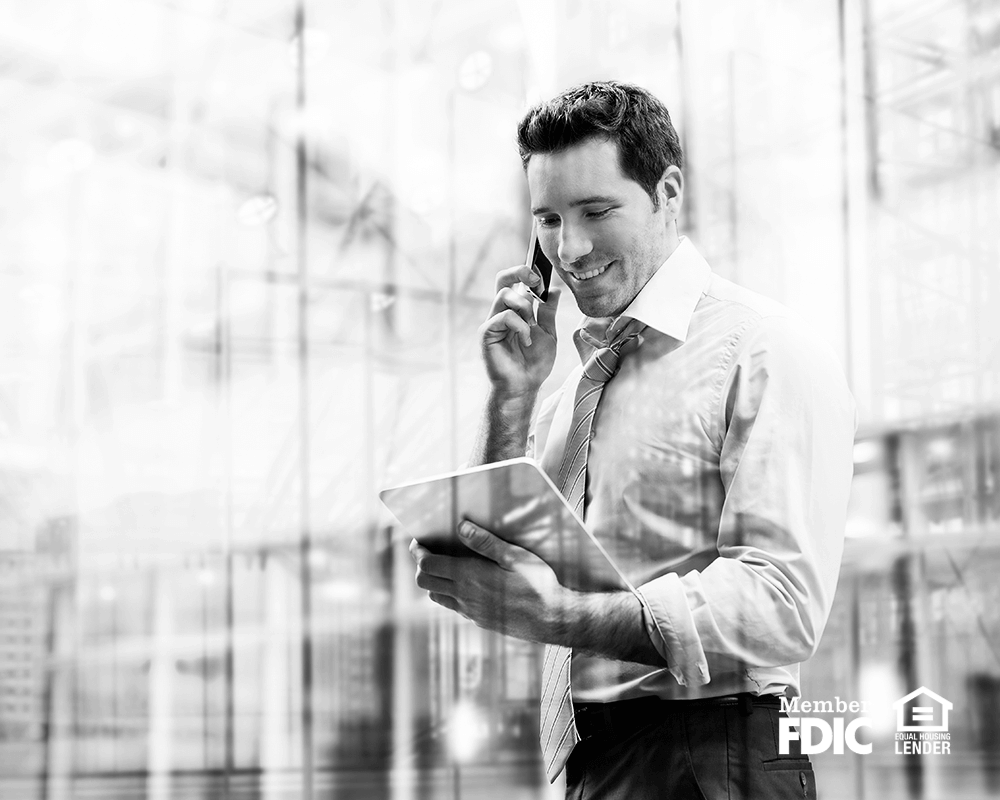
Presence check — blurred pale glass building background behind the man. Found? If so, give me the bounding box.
[0,0,1000,800]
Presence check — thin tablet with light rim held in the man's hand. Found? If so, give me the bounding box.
[379,458,632,592]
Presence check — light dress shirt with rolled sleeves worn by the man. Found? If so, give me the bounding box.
[529,238,856,702]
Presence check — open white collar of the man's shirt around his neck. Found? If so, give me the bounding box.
[573,236,712,360]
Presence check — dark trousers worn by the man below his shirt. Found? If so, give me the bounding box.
[566,695,816,800]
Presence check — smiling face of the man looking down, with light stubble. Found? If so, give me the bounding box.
[527,139,679,317]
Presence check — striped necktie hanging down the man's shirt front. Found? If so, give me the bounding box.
[539,318,646,783]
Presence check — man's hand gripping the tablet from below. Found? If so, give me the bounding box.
[410,521,575,643]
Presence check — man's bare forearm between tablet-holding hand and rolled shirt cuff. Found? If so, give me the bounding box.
[550,592,667,667]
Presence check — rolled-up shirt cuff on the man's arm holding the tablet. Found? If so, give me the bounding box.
[635,573,712,686]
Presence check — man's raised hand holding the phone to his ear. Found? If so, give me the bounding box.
[479,264,559,402]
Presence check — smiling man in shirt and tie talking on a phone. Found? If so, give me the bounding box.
[411,82,855,800]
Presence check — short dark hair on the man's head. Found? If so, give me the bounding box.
[517,81,684,208]
